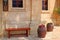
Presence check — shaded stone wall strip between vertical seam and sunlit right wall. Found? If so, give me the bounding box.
[31,0,41,35]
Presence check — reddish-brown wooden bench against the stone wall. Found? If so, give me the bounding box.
[6,28,30,38]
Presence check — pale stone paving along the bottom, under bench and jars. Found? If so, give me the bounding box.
[0,26,60,40]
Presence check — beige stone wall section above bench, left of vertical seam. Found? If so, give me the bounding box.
[3,0,31,28]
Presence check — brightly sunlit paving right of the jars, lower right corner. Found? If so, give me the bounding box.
[44,26,60,40]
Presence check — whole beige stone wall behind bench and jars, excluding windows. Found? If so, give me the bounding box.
[2,0,55,34]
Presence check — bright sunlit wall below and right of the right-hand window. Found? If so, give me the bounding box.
[41,0,56,24]
